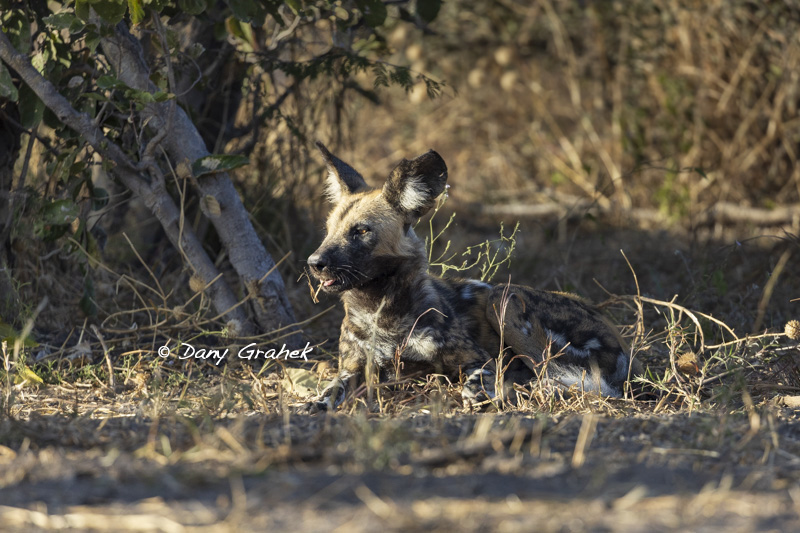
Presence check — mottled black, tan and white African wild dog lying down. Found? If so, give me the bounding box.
[307,142,638,411]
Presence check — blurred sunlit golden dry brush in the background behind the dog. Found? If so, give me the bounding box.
[260,0,800,243]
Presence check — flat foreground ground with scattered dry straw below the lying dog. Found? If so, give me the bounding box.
[0,380,800,531]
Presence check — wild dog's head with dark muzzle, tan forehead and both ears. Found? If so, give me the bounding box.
[308,142,447,293]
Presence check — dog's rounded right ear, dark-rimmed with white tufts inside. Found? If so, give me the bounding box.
[383,150,447,222]
